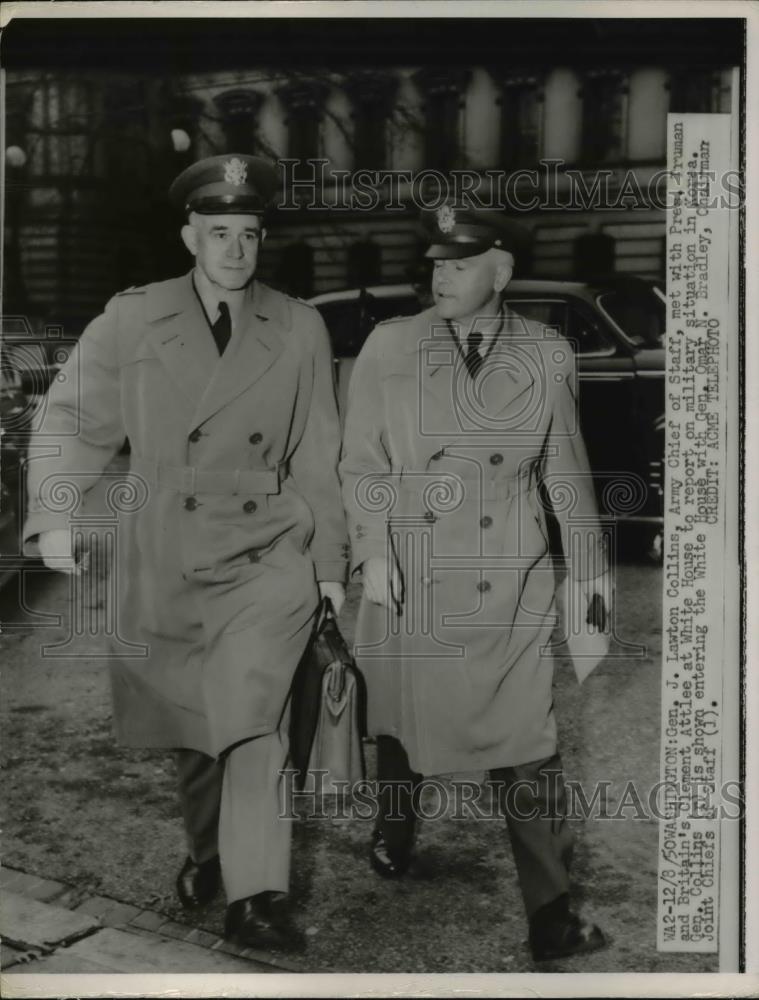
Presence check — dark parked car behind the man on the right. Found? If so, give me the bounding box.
[310,277,665,559]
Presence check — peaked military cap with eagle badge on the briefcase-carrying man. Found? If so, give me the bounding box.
[169,153,279,215]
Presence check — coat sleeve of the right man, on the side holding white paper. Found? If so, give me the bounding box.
[543,344,608,581]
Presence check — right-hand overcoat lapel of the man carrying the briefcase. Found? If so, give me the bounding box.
[194,282,290,424]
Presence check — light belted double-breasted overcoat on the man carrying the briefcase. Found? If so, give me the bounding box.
[25,274,348,755]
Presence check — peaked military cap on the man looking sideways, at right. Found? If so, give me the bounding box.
[422,202,530,260]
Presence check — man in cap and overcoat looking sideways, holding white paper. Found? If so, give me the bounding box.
[340,204,607,960]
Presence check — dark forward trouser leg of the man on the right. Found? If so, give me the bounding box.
[490,754,573,918]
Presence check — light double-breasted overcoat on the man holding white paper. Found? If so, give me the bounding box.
[340,307,605,774]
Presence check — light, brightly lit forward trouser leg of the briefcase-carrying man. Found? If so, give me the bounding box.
[219,732,292,903]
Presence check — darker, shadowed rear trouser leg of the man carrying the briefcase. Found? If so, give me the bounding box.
[174,750,223,864]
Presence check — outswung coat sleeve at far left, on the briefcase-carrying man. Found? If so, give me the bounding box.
[23,299,126,554]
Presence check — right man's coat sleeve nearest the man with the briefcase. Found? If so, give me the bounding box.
[340,329,393,572]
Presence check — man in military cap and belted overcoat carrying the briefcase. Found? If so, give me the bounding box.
[25,154,348,947]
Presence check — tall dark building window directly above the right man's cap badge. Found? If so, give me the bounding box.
[414,68,471,173]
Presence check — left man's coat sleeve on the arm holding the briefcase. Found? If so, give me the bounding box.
[290,306,349,581]
